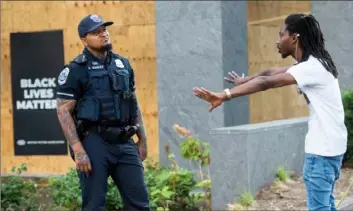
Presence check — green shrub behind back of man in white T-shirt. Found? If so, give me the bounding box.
[342,90,353,164]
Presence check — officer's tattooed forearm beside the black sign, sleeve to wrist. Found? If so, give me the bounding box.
[57,99,82,151]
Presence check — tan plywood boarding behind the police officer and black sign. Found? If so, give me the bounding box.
[1,1,159,174]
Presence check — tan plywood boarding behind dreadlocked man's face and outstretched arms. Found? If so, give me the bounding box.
[248,1,310,123]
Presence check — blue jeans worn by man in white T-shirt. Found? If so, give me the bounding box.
[303,153,343,210]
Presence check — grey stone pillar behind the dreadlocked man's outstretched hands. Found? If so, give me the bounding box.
[155,1,249,167]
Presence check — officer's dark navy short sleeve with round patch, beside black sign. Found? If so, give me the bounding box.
[56,65,82,100]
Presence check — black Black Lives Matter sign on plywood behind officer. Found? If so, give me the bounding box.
[10,30,68,155]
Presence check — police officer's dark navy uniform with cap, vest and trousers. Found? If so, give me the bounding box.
[56,16,149,211]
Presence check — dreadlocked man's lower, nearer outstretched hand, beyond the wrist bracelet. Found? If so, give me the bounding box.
[194,87,224,112]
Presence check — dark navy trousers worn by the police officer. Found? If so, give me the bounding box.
[78,133,150,211]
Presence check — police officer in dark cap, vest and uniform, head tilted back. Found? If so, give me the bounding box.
[56,15,149,211]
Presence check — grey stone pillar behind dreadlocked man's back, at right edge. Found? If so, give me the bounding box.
[311,1,353,91]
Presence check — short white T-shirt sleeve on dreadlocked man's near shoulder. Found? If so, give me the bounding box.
[287,63,319,88]
